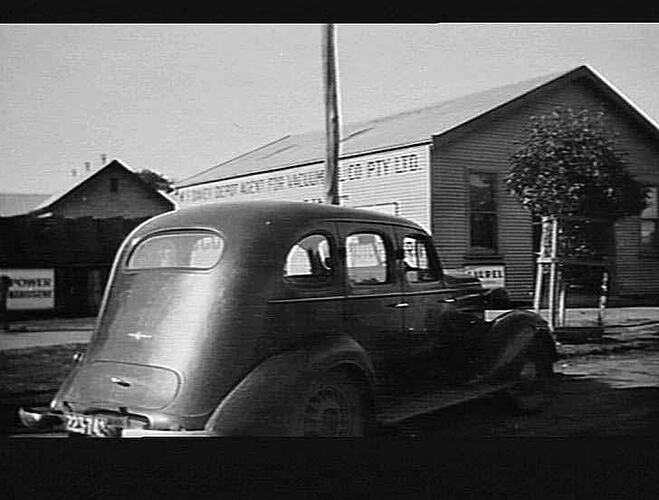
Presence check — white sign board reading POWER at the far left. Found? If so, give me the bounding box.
[0,269,55,310]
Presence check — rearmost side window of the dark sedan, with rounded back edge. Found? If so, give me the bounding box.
[284,234,334,285]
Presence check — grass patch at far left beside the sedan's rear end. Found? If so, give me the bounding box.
[0,343,87,398]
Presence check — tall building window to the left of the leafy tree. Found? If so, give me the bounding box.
[469,172,497,252]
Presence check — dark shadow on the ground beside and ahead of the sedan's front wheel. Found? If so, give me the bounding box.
[383,374,659,439]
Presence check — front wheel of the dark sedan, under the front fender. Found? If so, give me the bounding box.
[506,343,554,413]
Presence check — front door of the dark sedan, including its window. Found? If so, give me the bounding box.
[396,227,456,375]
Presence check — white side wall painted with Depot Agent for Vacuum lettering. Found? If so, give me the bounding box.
[175,145,430,229]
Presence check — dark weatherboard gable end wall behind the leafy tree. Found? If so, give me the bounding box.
[431,80,659,300]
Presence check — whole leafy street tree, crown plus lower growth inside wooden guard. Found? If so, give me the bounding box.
[506,107,646,304]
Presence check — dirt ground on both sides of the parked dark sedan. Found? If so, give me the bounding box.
[0,344,659,439]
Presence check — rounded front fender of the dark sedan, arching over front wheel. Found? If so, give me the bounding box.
[482,309,557,373]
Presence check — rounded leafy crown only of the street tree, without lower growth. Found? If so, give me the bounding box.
[506,107,646,221]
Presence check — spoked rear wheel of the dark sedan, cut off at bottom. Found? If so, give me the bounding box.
[302,371,367,437]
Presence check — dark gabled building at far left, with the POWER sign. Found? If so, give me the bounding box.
[0,160,175,318]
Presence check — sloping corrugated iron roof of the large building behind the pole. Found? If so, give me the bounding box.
[177,68,578,187]
